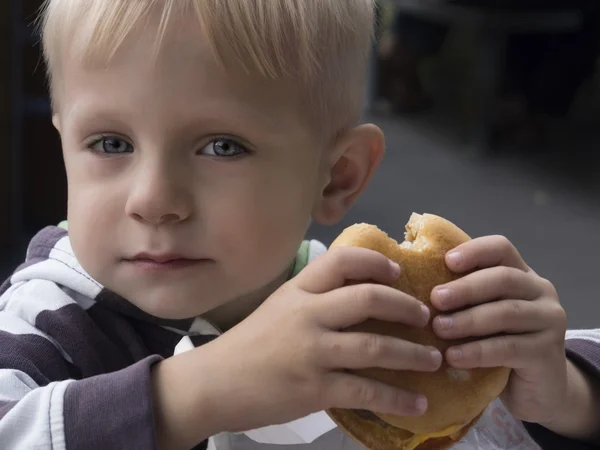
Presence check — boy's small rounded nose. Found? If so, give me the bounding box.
[125,160,193,226]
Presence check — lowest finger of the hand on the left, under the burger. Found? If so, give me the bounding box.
[325,372,427,416]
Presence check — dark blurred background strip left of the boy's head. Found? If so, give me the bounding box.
[0,0,66,270]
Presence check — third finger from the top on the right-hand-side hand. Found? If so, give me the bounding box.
[433,300,553,339]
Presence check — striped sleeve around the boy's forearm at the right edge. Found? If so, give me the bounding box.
[525,329,600,450]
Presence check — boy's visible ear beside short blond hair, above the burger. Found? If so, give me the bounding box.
[313,124,385,225]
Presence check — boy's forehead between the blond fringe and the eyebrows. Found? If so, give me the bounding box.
[55,14,312,137]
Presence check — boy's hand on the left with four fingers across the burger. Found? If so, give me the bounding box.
[150,247,442,448]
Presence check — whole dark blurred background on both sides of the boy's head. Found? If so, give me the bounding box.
[0,0,600,327]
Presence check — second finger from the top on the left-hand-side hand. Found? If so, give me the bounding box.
[316,284,430,330]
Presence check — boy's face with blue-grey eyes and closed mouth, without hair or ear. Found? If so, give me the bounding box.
[55,18,329,318]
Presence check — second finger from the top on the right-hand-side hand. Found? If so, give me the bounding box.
[431,266,543,311]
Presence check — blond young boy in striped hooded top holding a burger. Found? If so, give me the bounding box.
[0,0,600,450]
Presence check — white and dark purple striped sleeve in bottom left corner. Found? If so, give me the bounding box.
[0,300,161,450]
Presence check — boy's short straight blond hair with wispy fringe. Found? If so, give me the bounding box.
[40,0,375,137]
